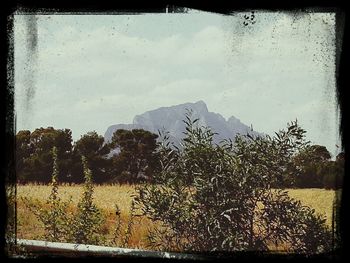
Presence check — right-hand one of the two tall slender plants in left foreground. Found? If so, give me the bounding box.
[71,156,103,244]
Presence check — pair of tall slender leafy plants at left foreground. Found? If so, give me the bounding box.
[23,150,104,244]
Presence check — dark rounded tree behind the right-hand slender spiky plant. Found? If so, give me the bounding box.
[71,131,111,183]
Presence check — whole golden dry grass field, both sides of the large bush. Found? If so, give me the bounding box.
[17,185,335,251]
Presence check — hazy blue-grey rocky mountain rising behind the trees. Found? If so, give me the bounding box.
[104,101,262,145]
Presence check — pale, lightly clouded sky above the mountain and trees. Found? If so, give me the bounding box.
[14,10,341,156]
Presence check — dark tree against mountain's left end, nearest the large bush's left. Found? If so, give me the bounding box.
[111,129,158,182]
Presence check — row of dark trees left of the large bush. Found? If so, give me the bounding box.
[16,127,158,183]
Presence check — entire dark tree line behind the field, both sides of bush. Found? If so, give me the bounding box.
[16,127,344,189]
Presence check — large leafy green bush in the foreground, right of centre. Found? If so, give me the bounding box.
[135,113,331,253]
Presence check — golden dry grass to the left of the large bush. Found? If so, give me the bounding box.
[17,184,152,248]
